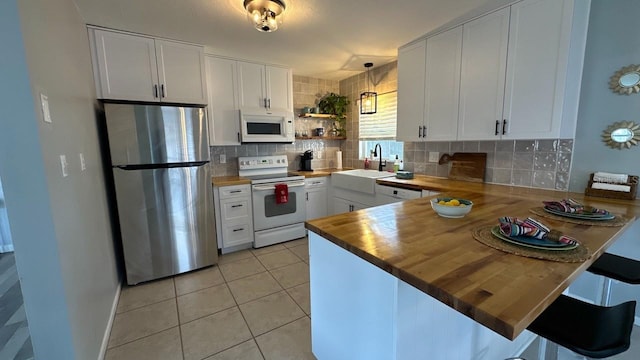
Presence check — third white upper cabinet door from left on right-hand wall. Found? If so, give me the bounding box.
[458,7,512,140]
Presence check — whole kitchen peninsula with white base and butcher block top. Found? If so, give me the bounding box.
[306,181,640,359]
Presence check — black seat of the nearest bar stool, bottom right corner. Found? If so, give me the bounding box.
[528,295,636,358]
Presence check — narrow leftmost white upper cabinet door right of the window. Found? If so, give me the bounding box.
[396,40,427,141]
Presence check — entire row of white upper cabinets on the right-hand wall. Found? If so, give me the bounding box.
[398,0,589,141]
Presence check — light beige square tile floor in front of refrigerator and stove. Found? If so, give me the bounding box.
[106,238,315,360]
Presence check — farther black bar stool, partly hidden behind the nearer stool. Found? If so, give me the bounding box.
[587,253,640,306]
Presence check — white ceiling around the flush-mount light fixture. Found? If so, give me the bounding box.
[74,0,513,80]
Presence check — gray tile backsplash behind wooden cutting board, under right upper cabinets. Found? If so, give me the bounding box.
[404,139,573,190]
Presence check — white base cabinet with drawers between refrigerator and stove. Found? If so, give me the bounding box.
[213,185,253,254]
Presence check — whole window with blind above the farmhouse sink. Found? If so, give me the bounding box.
[358,91,404,160]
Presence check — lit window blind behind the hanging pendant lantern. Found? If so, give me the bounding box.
[358,91,398,140]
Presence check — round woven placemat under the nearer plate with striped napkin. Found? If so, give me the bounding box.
[472,225,591,262]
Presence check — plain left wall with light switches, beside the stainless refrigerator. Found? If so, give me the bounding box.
[0,0,119,359]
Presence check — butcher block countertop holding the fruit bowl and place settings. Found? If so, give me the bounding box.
[306,184,640,339]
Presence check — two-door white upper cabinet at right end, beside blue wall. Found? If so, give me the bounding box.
[458,0,588,140]
